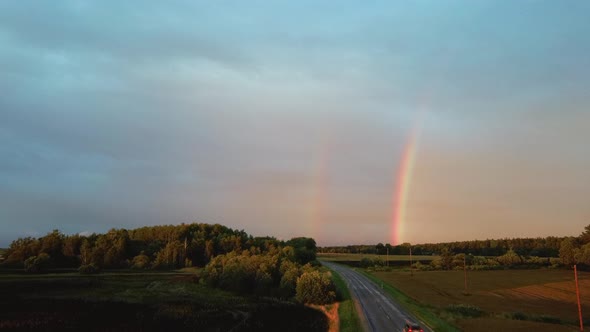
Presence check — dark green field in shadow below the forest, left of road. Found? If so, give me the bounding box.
[0,271,328,331]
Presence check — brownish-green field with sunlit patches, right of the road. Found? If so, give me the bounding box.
[373,269,590,331]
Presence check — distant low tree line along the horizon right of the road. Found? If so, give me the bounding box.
[328,225,590,270]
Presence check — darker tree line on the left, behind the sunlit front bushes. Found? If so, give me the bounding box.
[2,223,316,270]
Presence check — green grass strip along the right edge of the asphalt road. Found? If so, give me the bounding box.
[358,269,459,331]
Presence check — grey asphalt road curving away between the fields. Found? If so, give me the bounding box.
[322,262,430,332]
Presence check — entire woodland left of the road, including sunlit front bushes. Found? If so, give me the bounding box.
[2,223,336,304]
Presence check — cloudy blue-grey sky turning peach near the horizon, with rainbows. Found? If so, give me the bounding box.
[0,0,590,247]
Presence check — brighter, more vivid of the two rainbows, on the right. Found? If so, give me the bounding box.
[390,121,421,245]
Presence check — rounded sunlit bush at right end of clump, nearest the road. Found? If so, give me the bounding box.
[295,271,336,304]
